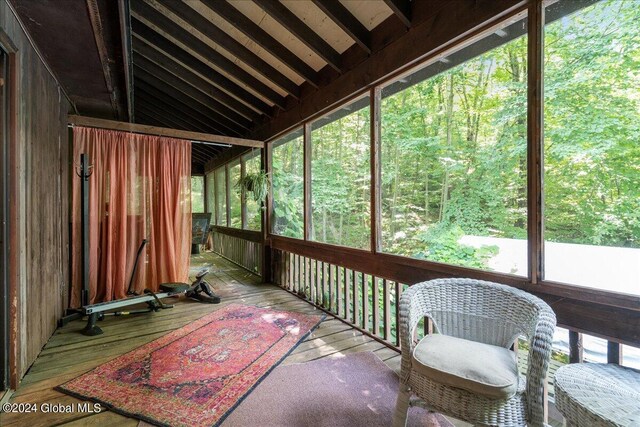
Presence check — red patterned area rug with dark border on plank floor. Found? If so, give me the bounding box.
[58,304,324,426]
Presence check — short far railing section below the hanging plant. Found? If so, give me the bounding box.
[211,226,264,276]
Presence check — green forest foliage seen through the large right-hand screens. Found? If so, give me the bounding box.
[272,0,640,272]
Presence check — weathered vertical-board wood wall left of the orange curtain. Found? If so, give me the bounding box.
[0,0,69,387]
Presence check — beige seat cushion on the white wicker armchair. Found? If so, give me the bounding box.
[413,334,518,399]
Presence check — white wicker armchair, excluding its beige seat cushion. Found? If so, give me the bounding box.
[394,279,556,427]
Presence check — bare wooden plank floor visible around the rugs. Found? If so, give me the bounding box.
[0,254,400,427]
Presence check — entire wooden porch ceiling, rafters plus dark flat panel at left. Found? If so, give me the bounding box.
[10,0,414,169]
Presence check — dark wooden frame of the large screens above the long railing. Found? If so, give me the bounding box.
[258,0,640,309]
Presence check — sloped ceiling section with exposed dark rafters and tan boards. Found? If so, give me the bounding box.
[131,0,409,136]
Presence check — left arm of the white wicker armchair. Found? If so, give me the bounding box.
[399,282,429,384]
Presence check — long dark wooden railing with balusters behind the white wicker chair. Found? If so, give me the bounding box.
[270,236,640,363]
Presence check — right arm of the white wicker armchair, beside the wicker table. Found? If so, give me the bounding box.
[526,301,556,426]
